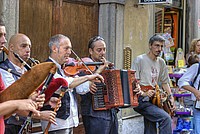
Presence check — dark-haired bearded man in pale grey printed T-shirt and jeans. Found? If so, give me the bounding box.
[132,35,174,134]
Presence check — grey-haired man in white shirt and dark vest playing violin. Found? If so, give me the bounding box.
[41,34,103,134]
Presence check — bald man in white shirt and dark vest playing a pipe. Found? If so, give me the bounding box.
[0,33,56,134]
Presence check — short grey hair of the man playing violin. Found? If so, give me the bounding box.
[49,34,69,53]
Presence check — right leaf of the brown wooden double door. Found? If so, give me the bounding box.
[61,0,98,57]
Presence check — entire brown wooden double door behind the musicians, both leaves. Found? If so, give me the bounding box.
[19,0,98,61]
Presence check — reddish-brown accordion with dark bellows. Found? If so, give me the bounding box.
[92,70,138,110]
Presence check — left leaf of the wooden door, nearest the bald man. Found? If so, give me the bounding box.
[19,0,52,61]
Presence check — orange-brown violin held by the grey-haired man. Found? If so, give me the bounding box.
[62,57,104,76]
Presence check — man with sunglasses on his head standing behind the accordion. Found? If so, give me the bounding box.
[80,36,139,134]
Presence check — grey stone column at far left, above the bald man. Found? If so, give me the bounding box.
[0,0,19,43]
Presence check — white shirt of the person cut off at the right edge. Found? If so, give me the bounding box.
[178,63,200,101]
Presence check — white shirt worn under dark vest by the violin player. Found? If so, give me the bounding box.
[41,57,89,131]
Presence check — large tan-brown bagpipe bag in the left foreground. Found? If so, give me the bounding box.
[0,62,56,103]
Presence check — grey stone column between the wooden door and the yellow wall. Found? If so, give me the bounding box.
[99,0,125,68]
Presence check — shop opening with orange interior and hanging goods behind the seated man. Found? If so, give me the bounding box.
[155,6,179,65]
